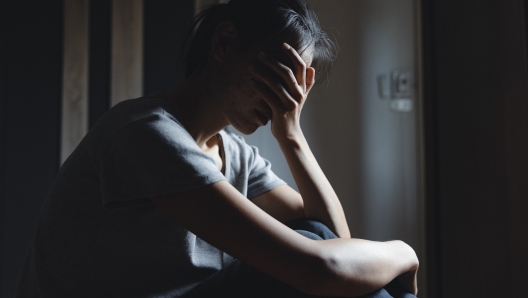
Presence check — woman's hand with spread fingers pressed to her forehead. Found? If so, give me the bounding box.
[249,43,315,141]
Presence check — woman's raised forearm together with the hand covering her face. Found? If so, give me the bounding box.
[250,44,350,238]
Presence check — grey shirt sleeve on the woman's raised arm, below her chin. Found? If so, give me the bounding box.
[246,145,286,199]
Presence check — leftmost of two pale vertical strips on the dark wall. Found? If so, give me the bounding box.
[60,0,89,164]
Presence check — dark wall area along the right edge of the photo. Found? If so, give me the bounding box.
[423,0,528,297]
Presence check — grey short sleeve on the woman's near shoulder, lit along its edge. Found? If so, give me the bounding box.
[96,114,225,208]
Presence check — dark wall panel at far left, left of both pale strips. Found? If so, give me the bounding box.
[0,0,62,297]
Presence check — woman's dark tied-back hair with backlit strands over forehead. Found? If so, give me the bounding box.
[183,0,336,81]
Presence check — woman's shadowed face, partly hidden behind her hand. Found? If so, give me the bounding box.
[213,41,313,135]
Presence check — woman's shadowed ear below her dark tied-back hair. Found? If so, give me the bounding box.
[211,21,238,62]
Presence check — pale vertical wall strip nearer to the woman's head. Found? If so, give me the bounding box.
[110,0,143,106]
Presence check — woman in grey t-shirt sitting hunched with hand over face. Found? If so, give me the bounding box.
[18,0,418,297]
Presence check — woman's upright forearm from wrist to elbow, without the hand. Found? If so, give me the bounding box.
[279,130,350,238]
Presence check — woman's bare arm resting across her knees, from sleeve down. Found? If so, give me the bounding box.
[150,181,418,297]
